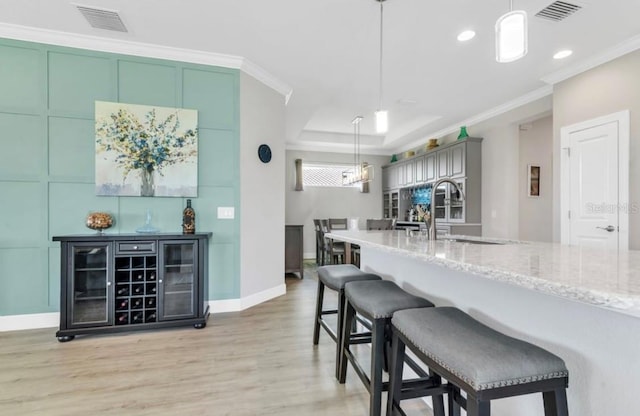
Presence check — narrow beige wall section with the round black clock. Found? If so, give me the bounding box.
[240,73,285,300]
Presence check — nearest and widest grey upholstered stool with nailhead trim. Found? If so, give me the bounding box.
[387,307,569,416]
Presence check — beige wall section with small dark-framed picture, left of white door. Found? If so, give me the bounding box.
[518,116,553,242]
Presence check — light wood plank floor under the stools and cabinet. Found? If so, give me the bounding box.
[0,269,430,416]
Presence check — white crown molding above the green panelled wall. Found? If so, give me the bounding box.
[0,23,293,104]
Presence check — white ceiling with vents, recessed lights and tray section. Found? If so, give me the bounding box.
[0,0,640,154]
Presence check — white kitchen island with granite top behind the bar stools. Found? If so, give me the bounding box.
[327,231,640,416]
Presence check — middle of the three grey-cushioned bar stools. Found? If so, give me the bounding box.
[338,280,444,416]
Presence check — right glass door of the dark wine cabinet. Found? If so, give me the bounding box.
[158,241,198,320]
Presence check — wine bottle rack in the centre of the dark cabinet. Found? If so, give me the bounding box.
[115,255,158,325]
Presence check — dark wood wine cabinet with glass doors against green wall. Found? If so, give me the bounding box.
[53,233,211,342]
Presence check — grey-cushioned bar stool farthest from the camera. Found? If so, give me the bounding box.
[313,264,382,378]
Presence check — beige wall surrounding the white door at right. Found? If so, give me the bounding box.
[553,51,640,250]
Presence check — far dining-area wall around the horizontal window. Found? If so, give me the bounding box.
[285,150,391,258]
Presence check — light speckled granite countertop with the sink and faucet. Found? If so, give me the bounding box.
[327,231,640,317]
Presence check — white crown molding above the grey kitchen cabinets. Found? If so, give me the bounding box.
[393,85,553,153]
